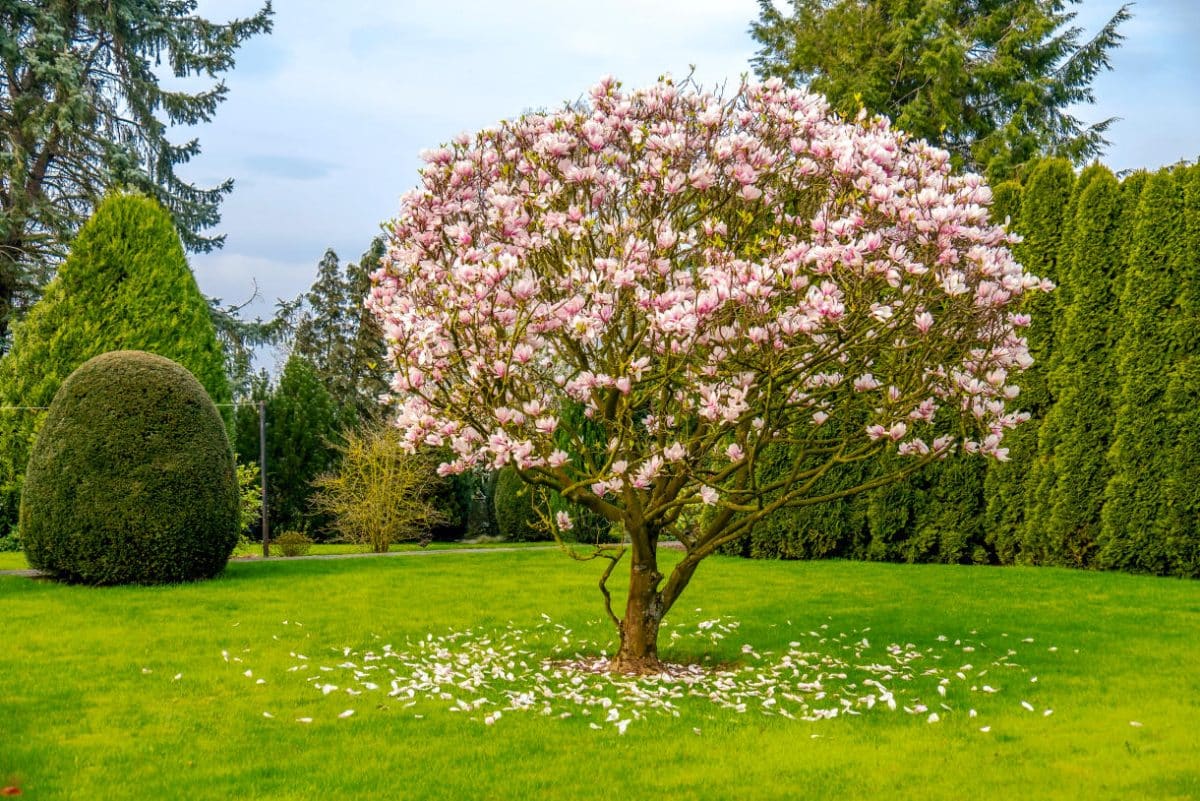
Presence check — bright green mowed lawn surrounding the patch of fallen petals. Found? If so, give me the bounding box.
[0,552,1200,801]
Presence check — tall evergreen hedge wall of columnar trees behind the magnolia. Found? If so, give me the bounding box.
[727,159,1200,577]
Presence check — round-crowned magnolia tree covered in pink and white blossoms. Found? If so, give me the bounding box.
[367,79,1049,671]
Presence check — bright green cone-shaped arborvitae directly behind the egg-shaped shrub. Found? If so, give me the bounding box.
[0,194,229,531]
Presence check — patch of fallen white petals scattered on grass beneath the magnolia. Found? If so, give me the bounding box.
[247,615,1046,735]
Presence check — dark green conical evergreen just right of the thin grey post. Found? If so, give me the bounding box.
[266,354,342,535]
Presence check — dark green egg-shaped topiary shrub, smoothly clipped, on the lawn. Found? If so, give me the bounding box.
[20,350,239,584]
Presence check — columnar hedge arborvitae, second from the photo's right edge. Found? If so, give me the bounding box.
[1097,169,1184,573]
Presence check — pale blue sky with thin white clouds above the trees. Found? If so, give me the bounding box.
[175,0,1200,333]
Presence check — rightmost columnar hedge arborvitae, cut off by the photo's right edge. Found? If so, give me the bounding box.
[1162,167,1200,577]
